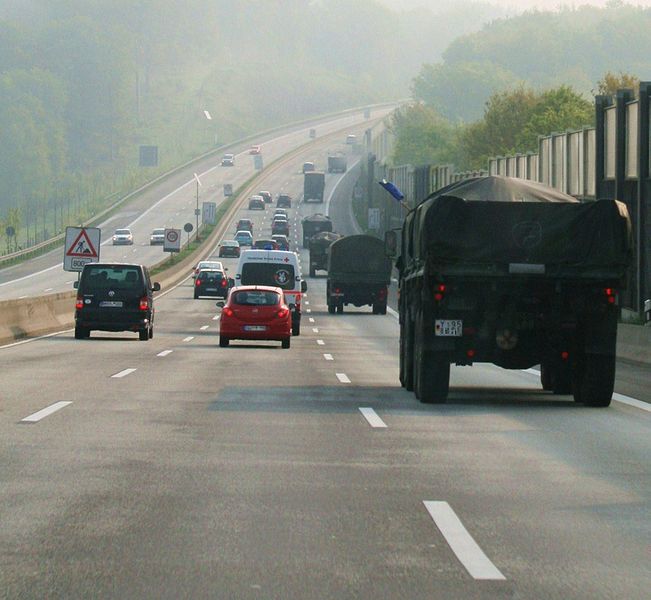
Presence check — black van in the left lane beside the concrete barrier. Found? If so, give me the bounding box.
[75,263,160,341]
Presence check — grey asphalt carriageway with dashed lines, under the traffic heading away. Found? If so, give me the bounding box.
[0,123,651,600]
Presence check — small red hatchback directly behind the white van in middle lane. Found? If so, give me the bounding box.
[219,285,292,348]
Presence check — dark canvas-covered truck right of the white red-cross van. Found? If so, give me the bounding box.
[326,235,392,315]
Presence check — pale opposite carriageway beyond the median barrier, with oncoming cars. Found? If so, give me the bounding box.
[0,107,391,300]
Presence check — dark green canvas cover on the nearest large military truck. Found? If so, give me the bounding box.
[412,177,631,274]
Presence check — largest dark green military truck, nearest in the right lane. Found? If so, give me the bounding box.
[394,177,631,406]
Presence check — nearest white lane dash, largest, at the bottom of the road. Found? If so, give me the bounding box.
[423,500,506,580]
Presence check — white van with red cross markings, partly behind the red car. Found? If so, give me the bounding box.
[235,249,307,335]
